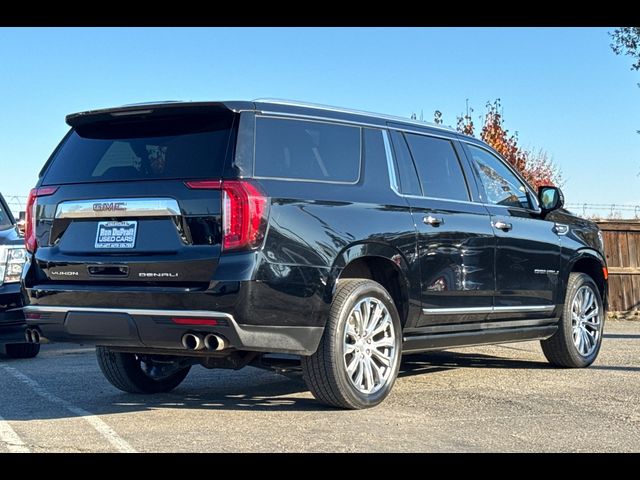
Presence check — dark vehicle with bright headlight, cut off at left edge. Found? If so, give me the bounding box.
[0,194,40,358]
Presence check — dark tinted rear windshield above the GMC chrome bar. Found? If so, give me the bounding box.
[43,112,233,185]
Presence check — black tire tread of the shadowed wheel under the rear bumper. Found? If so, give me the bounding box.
[96,347,191,393]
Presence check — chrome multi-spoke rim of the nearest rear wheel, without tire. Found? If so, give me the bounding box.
[343,297,398,395]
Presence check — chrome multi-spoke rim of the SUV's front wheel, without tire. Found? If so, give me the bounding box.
[571,285,602,357]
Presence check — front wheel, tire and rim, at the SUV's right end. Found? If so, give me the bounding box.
[540,272,605,368]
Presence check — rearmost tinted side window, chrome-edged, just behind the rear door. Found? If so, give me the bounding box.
[254,117,361,183]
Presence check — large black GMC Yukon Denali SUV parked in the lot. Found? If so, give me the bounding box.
[23,100,607,408]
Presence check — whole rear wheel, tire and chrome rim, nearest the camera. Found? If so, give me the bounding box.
[302,279,402,409]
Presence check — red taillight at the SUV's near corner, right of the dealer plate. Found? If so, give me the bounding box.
[185,180,269,250]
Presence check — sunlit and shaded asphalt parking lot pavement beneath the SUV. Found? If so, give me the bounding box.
[0,320,640,453]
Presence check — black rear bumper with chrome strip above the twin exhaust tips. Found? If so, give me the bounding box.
[24,306,324,355]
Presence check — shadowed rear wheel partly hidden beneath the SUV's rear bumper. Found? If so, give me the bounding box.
[96,347,191,393]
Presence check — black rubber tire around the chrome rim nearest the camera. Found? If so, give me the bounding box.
[302,279,402,409]
